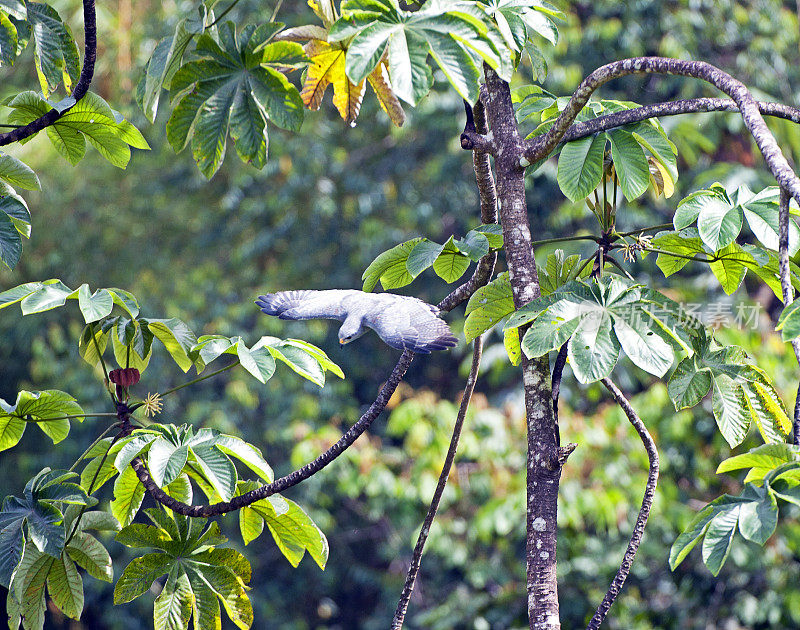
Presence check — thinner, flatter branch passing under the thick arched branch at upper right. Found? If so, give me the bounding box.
[536,98,800,147]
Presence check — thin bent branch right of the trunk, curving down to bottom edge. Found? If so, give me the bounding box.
[586,377,658,630]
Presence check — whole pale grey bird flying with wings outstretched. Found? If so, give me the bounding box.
[256,289,457,354]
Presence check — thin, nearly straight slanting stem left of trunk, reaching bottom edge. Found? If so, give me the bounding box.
[391,336,483,630]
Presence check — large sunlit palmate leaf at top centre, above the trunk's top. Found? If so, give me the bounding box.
[328,0,511,105]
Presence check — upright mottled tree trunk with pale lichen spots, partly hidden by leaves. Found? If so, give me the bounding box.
[486,68,562,630]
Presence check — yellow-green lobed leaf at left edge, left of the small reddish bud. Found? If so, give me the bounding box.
[0,389,83,450]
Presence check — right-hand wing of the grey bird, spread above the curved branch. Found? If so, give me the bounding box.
[364,294,458,354]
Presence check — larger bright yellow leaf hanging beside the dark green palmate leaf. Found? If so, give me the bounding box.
[300,40,366,124]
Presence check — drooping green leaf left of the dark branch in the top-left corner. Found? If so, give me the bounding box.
[26,2,80,97]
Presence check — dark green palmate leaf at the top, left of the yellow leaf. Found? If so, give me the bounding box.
[167,22,303,178]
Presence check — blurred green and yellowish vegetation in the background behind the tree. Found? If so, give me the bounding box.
[0,0,800,630]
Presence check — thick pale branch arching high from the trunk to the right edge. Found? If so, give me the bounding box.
[524,57,800,203]
